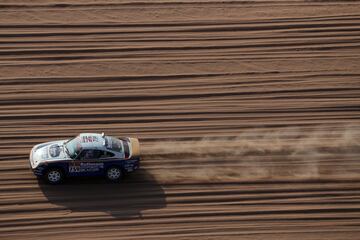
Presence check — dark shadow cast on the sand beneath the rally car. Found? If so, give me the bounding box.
[39,170,166,219]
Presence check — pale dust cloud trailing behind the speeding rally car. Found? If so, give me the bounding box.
[143,126,360,183]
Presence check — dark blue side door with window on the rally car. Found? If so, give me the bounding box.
[69,149,104,176]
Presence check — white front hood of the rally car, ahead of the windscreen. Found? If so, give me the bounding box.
[30,140,71,168]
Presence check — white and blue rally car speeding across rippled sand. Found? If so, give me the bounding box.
[30,133,140,184]
